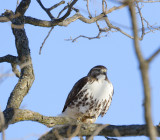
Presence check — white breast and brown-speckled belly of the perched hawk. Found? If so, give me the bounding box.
[78,76,113,118]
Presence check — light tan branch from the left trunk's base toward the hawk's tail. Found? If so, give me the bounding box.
[0,108,77,132]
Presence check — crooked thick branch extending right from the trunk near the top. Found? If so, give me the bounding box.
[0,3,126,27]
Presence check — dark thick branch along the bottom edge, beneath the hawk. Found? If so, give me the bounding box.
[39,124,160,140]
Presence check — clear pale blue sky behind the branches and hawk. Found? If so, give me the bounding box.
[0,0,160,140]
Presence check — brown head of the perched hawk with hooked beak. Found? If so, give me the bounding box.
[88,65,107,78]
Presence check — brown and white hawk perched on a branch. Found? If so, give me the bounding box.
[61,65,113,123]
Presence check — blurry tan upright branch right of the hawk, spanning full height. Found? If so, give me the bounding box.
[128,1,157,140]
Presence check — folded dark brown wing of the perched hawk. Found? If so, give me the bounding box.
[62,76,90,112]
